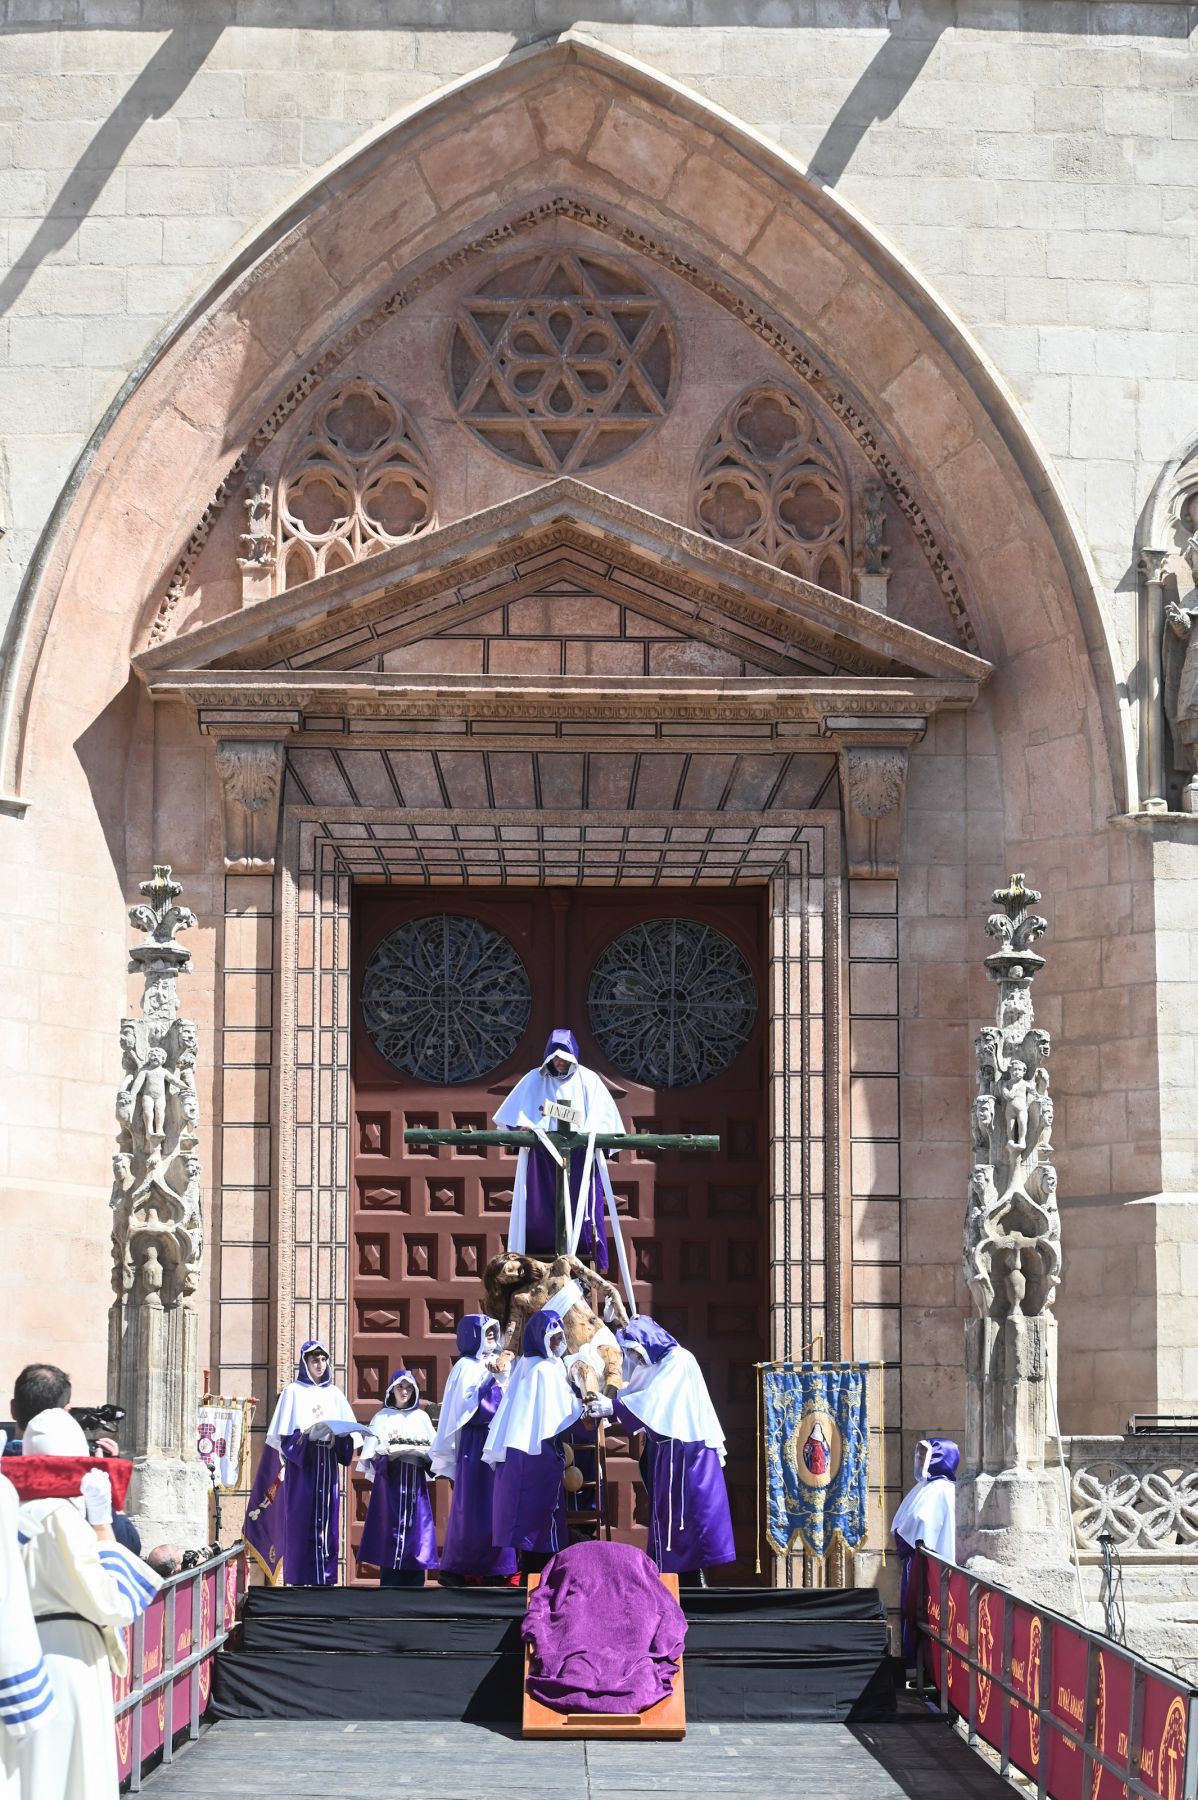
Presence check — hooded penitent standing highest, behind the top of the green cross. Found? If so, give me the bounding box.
[495,1030,624,1269]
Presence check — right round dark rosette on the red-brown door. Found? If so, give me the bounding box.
[586,918,757,1087]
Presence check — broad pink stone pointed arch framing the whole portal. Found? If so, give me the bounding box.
[4,32,1124,820]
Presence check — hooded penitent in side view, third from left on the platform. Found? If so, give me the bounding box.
[432,1312,516,1577]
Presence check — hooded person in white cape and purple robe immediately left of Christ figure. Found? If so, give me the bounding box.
[482,1310,583,1553]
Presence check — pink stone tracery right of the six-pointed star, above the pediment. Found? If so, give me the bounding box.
[693,387,851,594]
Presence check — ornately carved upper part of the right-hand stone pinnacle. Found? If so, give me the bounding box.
[964,875,1061,1318]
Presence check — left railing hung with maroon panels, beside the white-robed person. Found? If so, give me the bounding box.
[112,1543,245,1793]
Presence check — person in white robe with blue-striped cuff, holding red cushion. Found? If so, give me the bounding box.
[18,1409,162,1800]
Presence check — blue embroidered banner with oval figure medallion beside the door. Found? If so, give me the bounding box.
[763,1363,869,1557]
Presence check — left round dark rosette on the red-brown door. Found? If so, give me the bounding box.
[362,913,532,1084]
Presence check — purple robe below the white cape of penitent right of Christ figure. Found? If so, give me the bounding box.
[615,1400,736,1575]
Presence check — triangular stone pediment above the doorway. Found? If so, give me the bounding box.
[135,479,989,691]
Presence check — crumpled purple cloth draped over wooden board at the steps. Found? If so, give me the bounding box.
[520,1543,687,1712]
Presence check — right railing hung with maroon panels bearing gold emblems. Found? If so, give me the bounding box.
[910,1548,1198,1800]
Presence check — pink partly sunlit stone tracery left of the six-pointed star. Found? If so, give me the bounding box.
[277,382,435,592]
